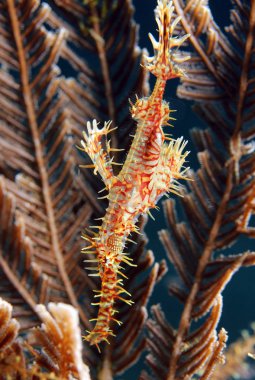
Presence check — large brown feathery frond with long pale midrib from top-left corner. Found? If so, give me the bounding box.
[0,0,95,338]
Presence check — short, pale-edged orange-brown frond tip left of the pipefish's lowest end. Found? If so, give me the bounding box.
[29,303,90,380]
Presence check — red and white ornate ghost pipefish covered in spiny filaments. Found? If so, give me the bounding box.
[78,0,189,347]
